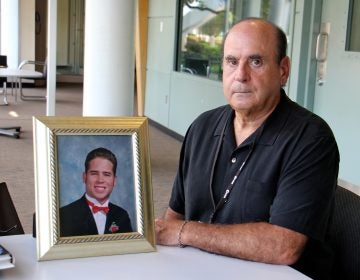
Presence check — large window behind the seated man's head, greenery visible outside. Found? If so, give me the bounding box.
[175,0,292,80]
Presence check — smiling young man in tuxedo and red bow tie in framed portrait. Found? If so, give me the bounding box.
[60,148,133,237]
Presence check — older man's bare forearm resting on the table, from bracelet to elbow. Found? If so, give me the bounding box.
[181,222,307,265]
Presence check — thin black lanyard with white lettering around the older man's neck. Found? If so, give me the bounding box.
[209,111,264,223]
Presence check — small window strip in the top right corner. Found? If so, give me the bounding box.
[346,0,360,52]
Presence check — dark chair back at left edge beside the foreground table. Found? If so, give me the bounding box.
[0,182,24,236]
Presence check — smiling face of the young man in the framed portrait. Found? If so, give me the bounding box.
[83,157,116,204]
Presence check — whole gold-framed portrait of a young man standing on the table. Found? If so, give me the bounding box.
[33,116,156,261]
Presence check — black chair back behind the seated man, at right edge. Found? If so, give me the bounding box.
[330,186,360,280]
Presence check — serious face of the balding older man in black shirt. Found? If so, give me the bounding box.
[223,21,290,115]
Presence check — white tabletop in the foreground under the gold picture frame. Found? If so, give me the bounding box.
[0,235,310,280]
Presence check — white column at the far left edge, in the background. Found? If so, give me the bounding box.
[0,0,20,68]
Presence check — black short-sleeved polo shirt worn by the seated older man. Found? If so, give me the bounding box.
[170,91,339,276]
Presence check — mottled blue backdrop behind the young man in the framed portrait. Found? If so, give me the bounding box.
[57,135,137,230]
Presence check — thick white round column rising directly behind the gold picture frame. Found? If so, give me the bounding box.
[83,0,135,116]
